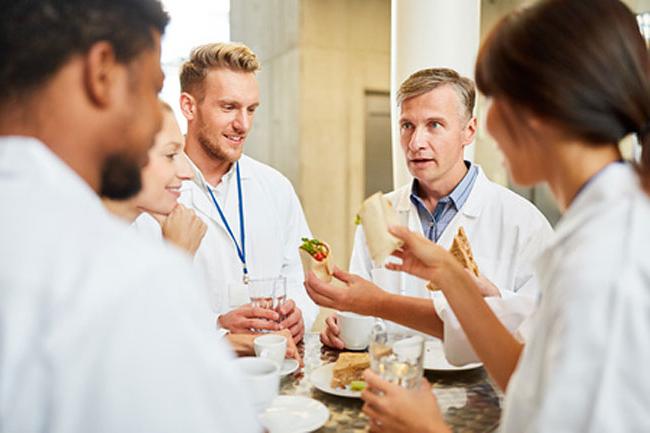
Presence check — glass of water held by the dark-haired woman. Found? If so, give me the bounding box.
[370,320,424,389]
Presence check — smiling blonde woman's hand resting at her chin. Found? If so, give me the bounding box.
[159,204,208,255]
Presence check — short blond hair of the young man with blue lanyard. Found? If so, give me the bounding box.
[180,42,260,99]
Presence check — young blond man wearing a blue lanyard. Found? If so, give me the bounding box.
[175,43,318,342]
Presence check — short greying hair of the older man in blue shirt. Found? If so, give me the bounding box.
[397,68,476,120]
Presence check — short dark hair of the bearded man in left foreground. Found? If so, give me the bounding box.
[0,0,169,103]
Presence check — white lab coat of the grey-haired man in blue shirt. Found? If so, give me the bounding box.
[350,167,552,365]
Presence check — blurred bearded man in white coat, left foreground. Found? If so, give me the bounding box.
[0,0,260,433]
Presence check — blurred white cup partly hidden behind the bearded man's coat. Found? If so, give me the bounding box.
[235,356,280,412]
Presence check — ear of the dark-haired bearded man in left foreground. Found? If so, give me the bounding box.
[84,42,120,107]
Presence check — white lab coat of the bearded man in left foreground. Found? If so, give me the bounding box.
[0,137,261,433]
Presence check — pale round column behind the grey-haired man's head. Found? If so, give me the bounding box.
[391,0,481,188]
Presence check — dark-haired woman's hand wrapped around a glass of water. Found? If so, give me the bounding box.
[361,369,450,433]
